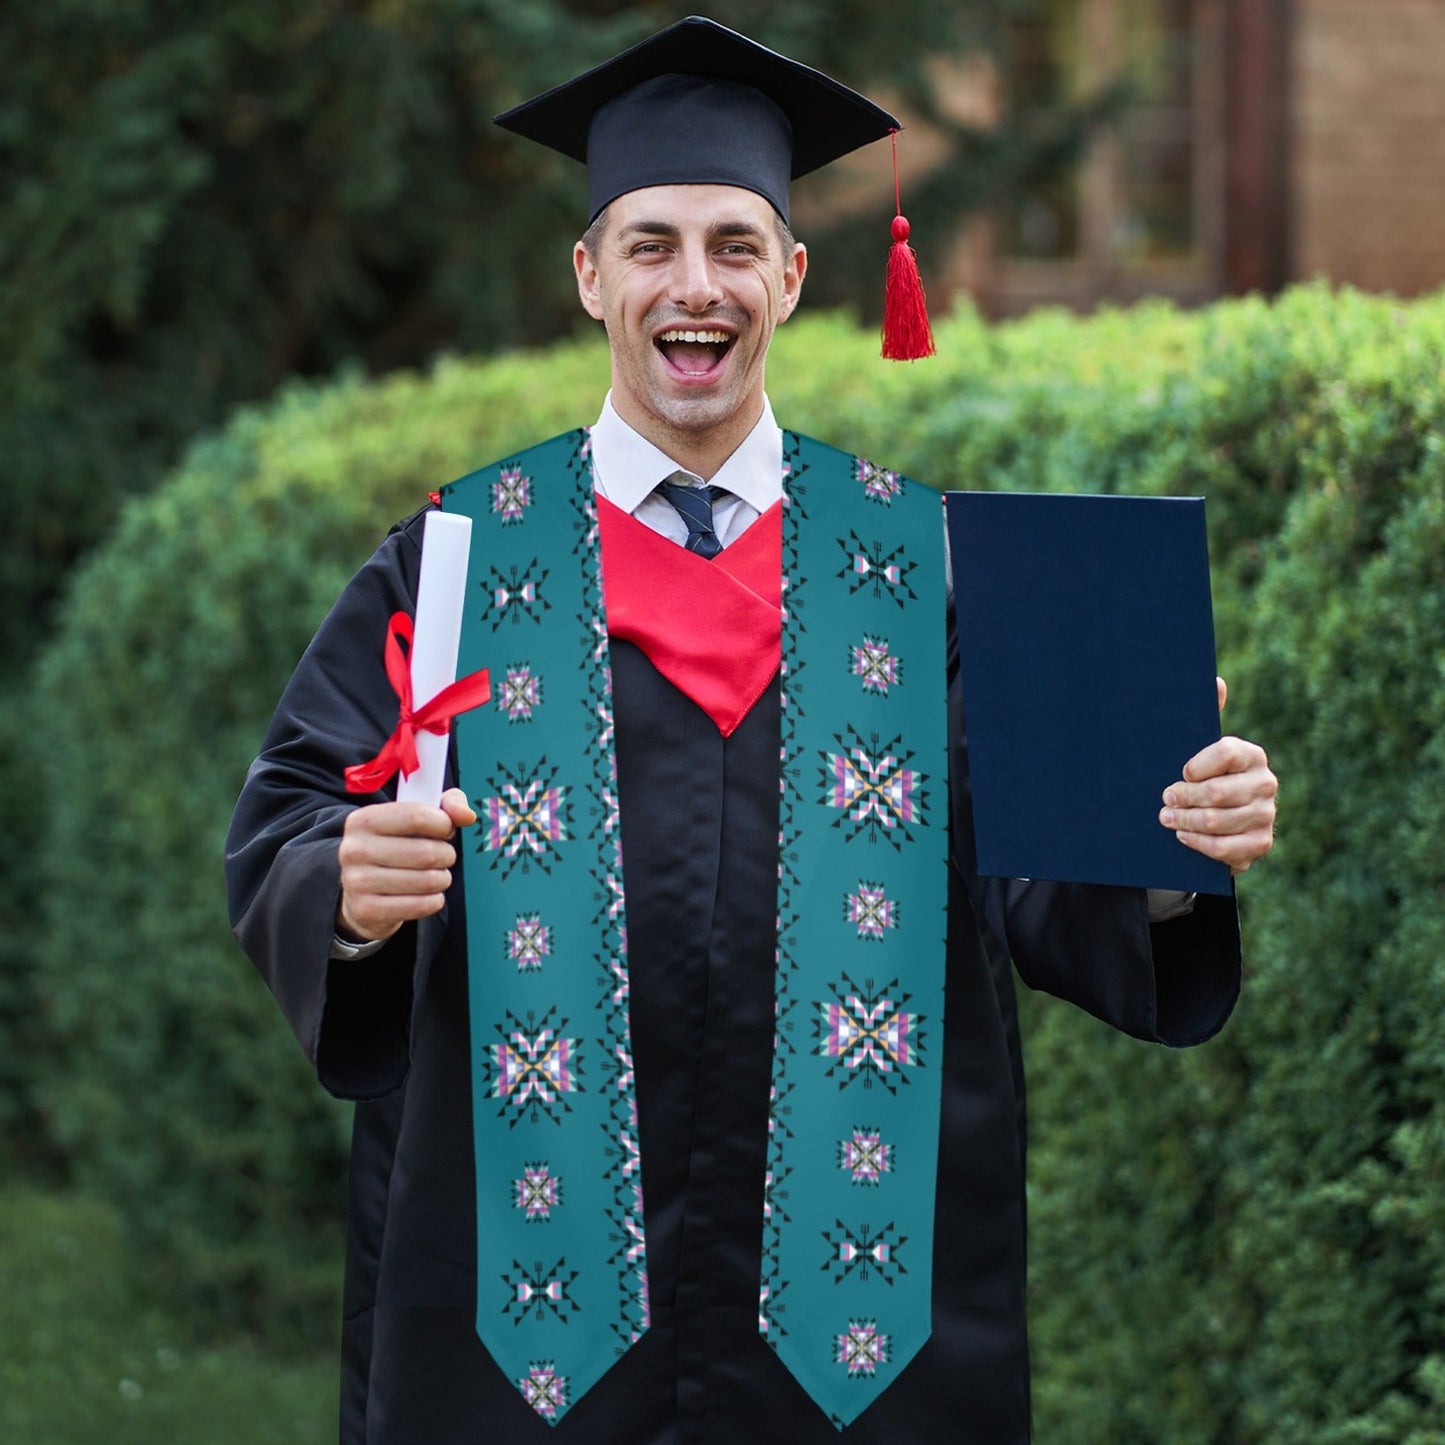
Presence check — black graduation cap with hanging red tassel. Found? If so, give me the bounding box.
[496,16,933,357]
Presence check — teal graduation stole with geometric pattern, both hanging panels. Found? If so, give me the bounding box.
[442,431,948,1429]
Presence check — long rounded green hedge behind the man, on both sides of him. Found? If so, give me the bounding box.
[28,289,1445,1445]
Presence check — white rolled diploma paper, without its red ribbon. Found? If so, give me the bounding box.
[396,512,471,808]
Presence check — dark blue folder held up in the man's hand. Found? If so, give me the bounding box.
[946,491,1230,893]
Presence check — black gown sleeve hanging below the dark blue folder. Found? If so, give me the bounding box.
[948,607,1241,1046]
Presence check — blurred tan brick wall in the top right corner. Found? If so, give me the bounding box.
[1290,0,1445,295]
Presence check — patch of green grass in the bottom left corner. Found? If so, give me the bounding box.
[0,1189,340,1445]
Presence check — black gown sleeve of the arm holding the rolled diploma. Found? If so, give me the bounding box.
[225,512,444,1098]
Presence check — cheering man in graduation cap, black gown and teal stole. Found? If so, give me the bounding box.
[228,20,1274,1445]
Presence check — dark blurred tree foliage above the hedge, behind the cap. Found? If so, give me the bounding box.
[0,0,1068,656]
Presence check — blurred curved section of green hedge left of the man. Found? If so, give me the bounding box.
[36,347,601,1337]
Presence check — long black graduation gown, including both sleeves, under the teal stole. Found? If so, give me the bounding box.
[227,499,1240,1445]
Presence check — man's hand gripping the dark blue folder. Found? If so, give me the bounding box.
[1159,678,1279,873]
